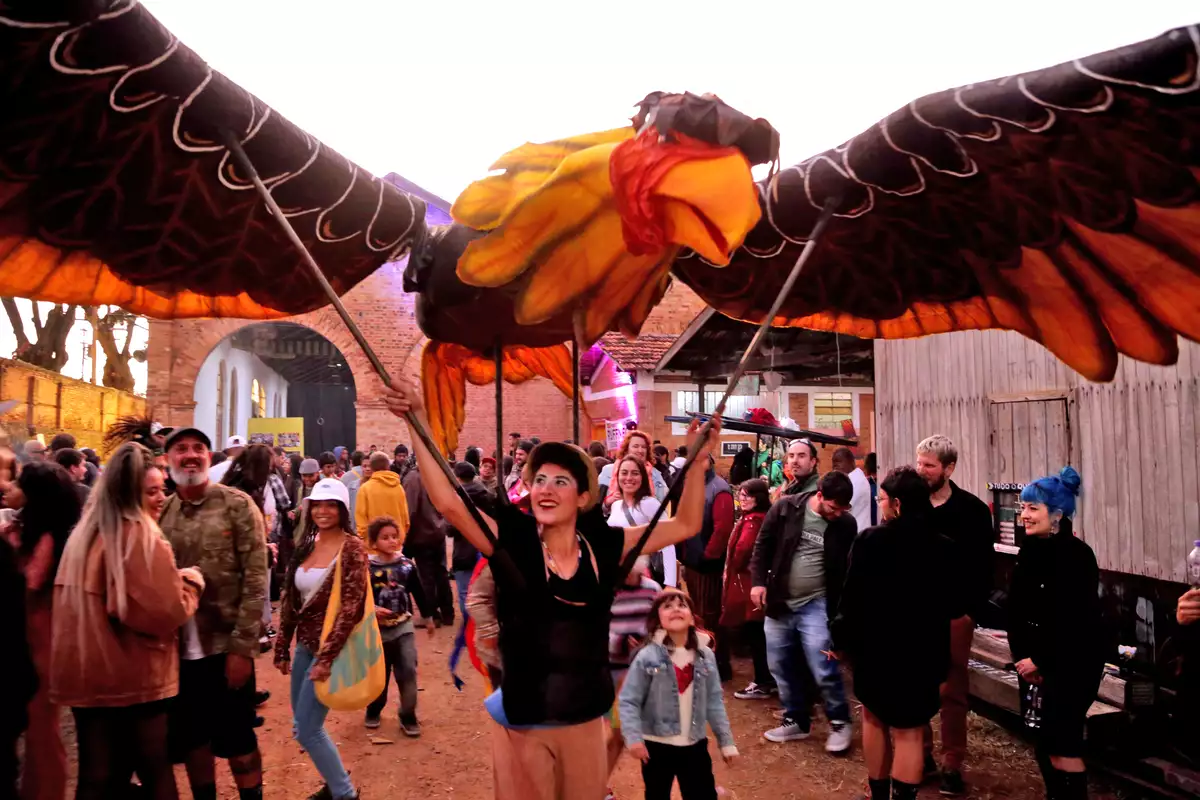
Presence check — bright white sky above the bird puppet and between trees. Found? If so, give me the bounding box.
[0,0,1200,391]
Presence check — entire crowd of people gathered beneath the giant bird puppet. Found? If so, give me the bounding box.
[0,395,1200,800]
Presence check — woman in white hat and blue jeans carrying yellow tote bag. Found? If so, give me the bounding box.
[275,479,383,800]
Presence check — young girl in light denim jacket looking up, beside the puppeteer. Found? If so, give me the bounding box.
[618,589,738,800]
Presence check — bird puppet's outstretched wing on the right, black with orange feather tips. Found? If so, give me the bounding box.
[674,28,1200,380]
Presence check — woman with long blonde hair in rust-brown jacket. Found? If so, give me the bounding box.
[50,443,204,800]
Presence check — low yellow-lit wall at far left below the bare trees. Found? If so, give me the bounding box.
[0,359,146,452]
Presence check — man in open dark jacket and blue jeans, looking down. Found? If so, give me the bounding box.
[750,473,858,753]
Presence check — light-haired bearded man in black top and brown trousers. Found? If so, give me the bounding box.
[917,435,996,798]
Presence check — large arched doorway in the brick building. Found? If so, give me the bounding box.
[193,323,358,456]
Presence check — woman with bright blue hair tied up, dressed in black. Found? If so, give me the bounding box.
[1008,467,1105,800]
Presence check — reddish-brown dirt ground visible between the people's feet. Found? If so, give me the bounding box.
[169,628,1129,800]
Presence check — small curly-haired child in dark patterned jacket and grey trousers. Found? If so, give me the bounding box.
[365,517,434,738]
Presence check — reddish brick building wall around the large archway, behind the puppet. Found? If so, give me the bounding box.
[146,264,580,455]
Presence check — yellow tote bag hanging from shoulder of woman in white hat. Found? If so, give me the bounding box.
[314,553,388,711]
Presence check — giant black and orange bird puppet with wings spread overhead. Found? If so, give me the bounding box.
[0,0,1200,449]
